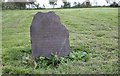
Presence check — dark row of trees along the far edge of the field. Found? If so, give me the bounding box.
[1,0,119,9]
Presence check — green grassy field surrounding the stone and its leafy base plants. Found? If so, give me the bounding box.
[0,8,118,74]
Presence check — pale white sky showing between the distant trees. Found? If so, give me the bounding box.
[37,0,120,8]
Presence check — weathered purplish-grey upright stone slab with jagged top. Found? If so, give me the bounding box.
[30,12,70,58]
